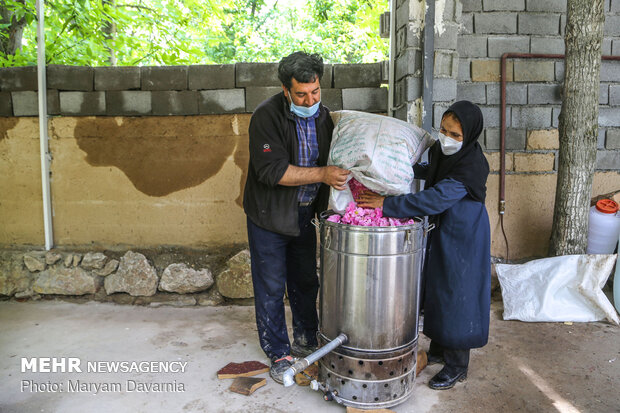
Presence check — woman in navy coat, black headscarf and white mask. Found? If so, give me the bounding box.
[356,101,491,390]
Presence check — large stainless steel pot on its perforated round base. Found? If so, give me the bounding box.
[319,215,425,408]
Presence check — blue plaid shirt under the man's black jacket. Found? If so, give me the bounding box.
[293,110,321,202]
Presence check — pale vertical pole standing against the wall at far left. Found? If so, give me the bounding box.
[36,0,54,250]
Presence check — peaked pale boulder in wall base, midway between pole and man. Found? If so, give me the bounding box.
[104,251,159,297]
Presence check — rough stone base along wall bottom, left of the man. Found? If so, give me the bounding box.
[0,247,253,307]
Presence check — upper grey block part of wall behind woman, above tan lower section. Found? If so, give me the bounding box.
[457,0,620,174]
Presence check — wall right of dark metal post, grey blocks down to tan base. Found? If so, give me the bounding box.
[456,0,620,259]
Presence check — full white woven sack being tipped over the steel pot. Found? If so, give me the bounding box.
[327,110,435,213]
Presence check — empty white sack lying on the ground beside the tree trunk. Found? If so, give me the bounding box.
[495,254,620,325]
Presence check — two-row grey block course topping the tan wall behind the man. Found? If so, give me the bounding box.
[0,63,387,117]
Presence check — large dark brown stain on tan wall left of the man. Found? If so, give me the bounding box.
[74,117,242,197]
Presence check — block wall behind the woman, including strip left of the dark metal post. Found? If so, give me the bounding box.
[394,0,620,259]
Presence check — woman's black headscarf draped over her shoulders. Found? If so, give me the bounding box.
[424,100,489,202]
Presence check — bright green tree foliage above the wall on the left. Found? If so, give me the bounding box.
[0,0,388,66]
